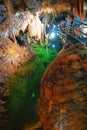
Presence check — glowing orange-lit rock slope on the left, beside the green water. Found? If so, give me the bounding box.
[0,38,32,83]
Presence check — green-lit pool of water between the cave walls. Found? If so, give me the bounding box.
[6,45,58,130]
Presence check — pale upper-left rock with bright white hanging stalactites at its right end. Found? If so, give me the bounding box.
[0,11,44,41]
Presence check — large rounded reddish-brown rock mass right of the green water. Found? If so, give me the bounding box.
[39,43,87,130]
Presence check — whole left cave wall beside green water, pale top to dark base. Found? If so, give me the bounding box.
[0,13,34,126]
